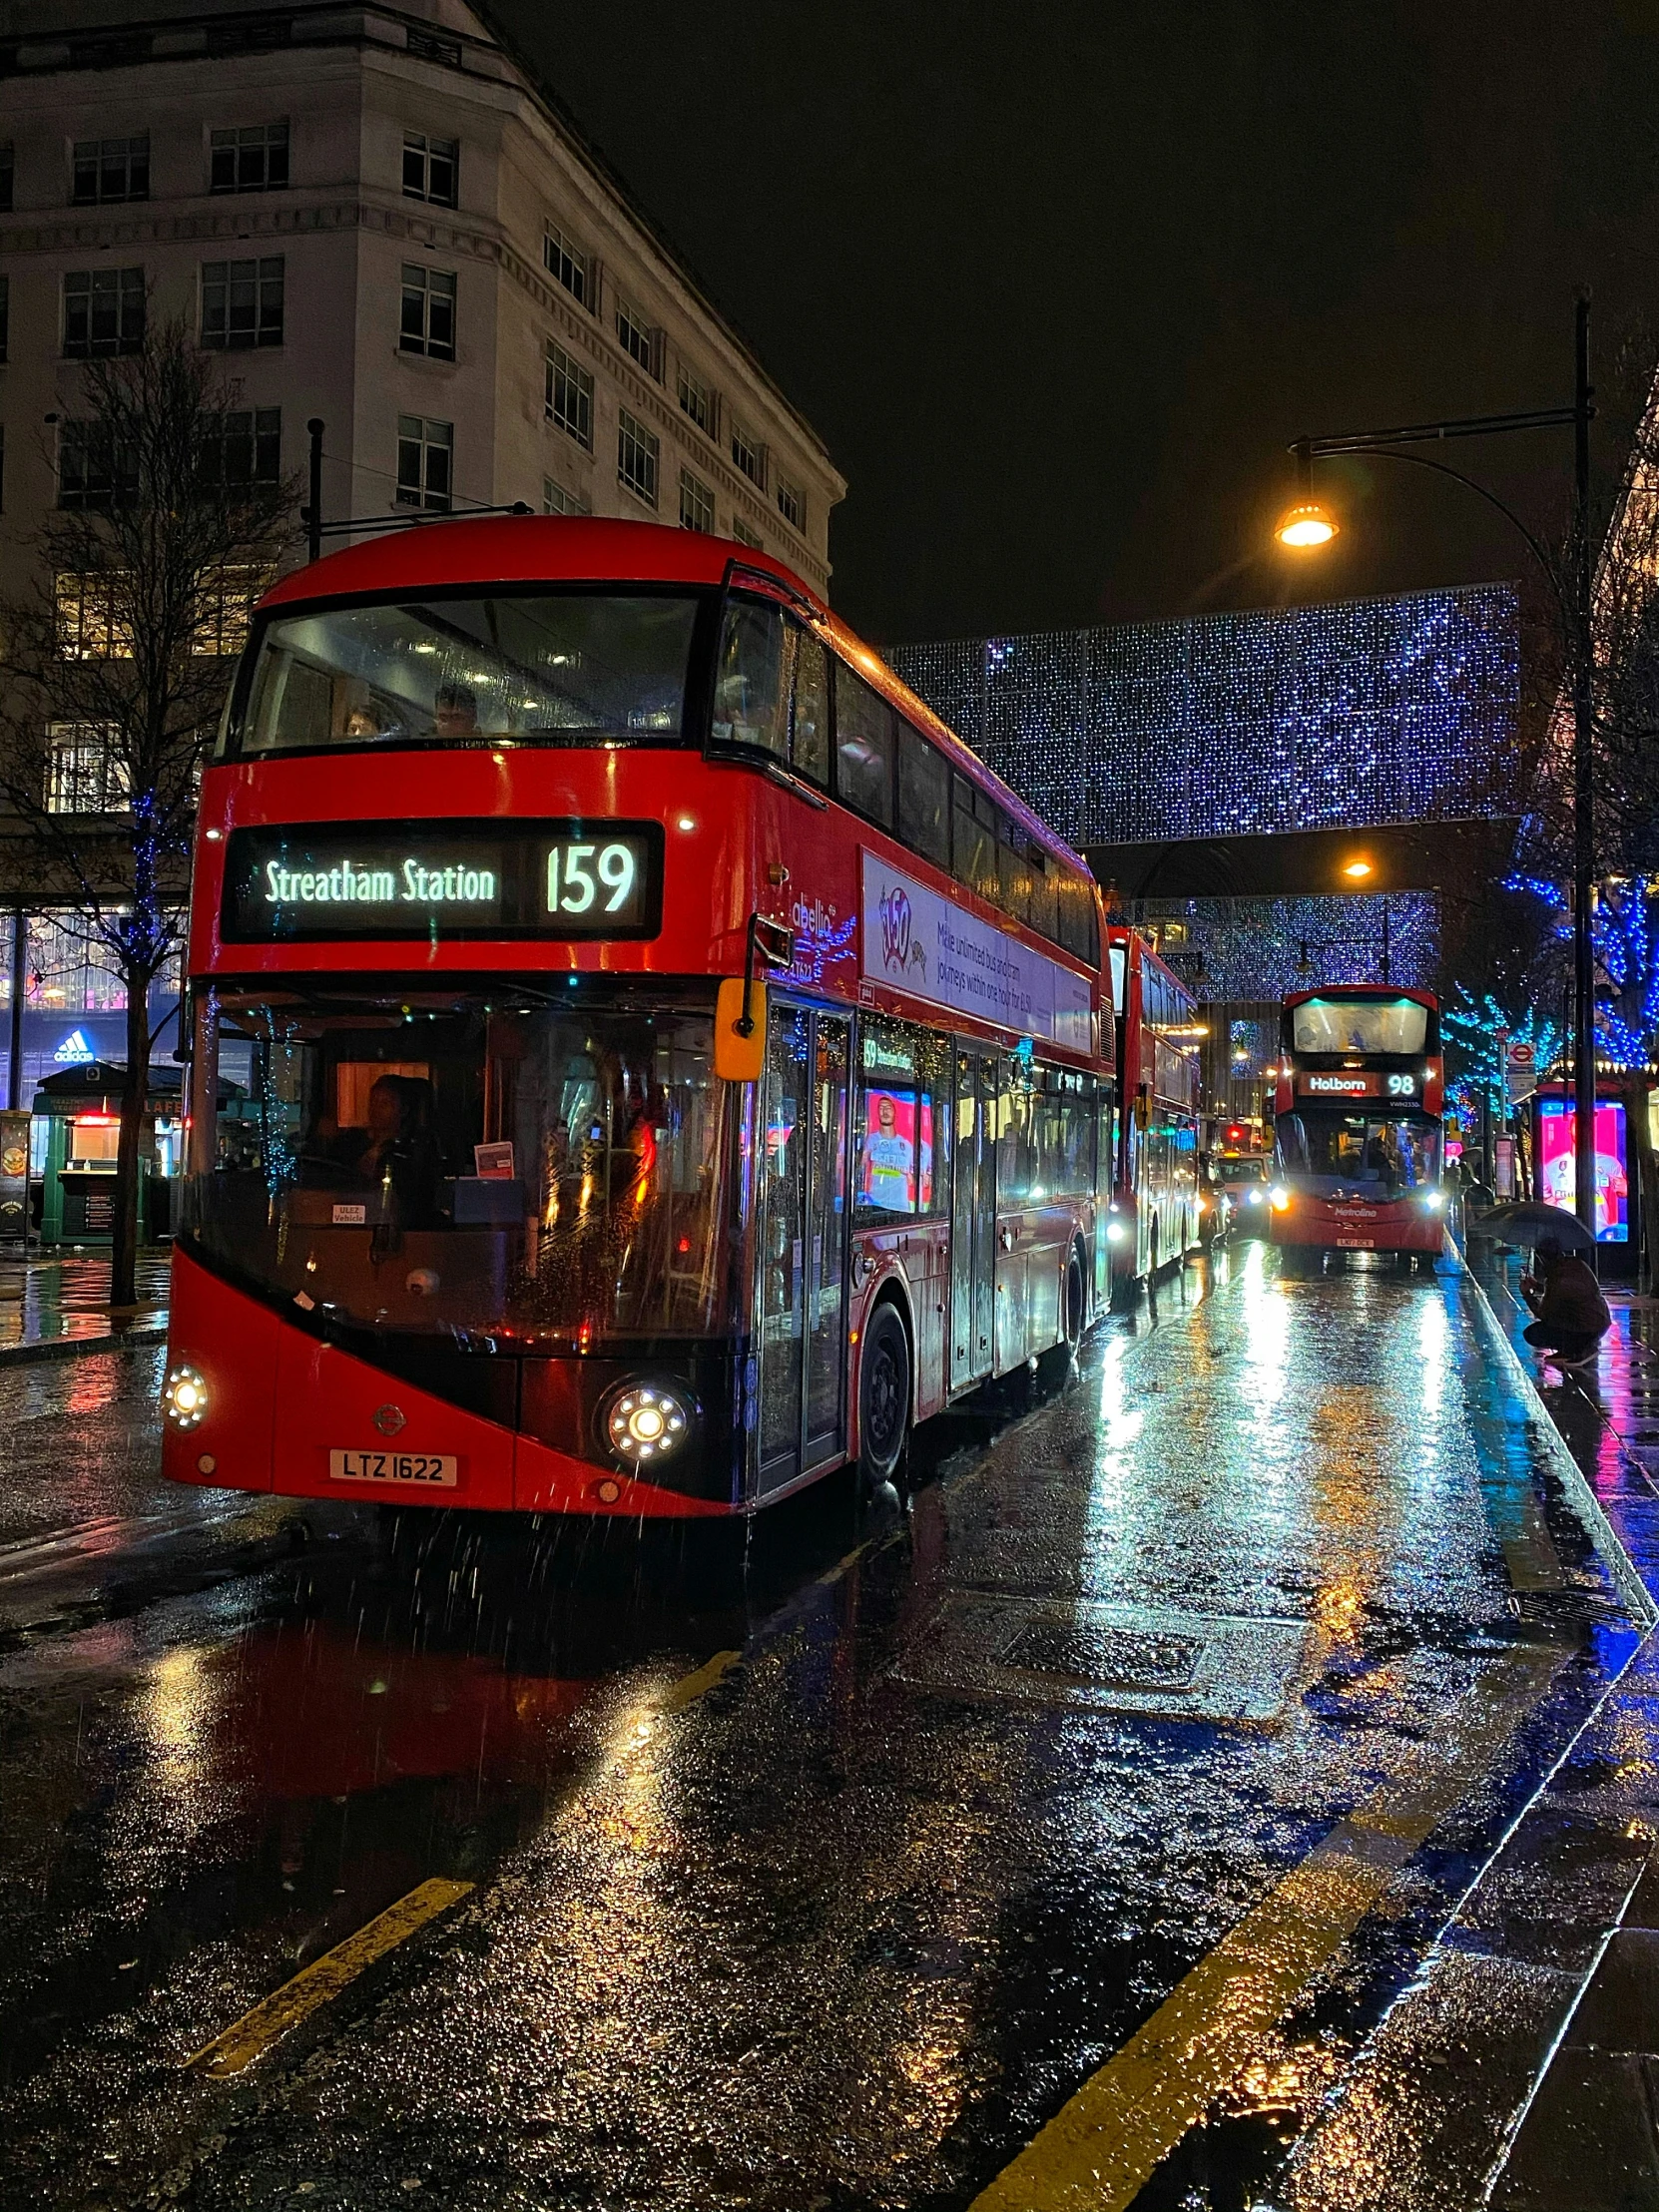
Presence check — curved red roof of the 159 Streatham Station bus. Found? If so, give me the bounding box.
[259,515,1093,880]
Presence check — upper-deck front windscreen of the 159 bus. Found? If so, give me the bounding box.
[230,591,699,755]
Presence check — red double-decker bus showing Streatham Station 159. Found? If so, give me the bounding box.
[164,518,1115,1515]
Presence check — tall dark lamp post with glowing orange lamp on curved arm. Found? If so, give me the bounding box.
[1274,292,1595,1235]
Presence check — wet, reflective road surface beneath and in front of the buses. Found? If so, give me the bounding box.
[0,1246,1635,2212]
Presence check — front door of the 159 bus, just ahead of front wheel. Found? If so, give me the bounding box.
[759,997,849,1497]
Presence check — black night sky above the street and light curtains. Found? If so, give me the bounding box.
[495,0,1659,642]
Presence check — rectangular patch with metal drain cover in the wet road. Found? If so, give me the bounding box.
[893,1590,1310,1728]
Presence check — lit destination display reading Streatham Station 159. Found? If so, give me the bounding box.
[222,821,662,944]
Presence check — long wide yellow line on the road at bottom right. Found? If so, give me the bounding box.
[971,1648,1564,2212]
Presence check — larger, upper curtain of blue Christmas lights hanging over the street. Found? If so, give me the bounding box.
[889,584,1519,845]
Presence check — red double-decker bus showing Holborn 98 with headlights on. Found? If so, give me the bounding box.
[1268,984,1446,1272]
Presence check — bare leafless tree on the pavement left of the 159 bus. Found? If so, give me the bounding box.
[0,320,296,1305]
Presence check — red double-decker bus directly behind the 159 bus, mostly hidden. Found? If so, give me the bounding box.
[1106,922,1206,1305]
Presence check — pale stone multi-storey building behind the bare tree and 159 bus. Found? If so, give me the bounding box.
[0,0,845,1088]
